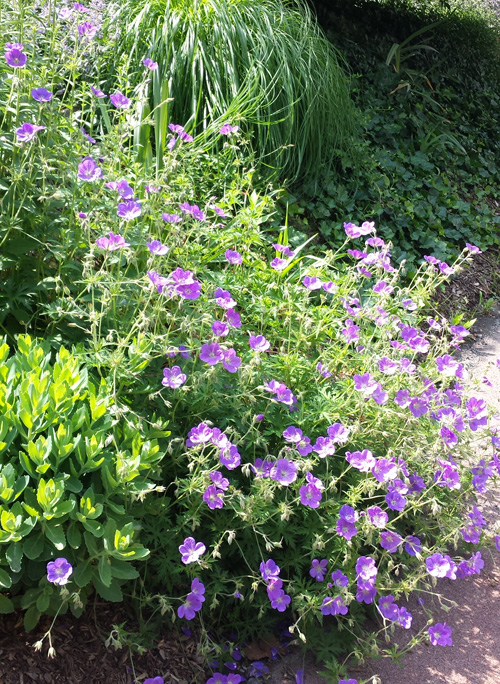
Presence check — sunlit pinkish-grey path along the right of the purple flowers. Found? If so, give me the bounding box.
[270,305,500,684]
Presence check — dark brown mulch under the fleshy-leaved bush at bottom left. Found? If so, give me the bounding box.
[0,602,206,684]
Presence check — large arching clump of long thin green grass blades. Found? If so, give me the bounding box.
[103,0,355,186]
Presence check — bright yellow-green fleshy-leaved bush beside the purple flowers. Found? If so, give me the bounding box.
[0,335,168,629]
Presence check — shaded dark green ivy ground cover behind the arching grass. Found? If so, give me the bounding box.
[288,0,500,269]
